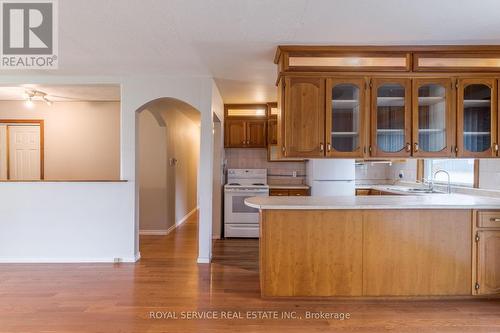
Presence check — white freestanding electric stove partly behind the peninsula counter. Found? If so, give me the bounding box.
[224,169,269,237]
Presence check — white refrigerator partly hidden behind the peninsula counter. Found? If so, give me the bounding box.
[307,159,356,197]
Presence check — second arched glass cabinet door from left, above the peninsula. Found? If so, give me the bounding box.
[371,78,411,157]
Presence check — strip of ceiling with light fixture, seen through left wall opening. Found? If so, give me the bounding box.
[0,84,120,102]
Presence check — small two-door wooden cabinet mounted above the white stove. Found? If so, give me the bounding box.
[224,118,267,148]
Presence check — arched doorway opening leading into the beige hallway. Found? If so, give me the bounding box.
[136,98,201,259]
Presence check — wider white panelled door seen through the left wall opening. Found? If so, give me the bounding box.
[8,125,41,180]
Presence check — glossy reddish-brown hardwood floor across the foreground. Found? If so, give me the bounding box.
[0,213,500,333]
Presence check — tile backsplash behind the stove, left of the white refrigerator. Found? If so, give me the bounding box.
[225,148,306,185]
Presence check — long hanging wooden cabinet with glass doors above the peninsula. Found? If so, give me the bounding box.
[275,45,500,158]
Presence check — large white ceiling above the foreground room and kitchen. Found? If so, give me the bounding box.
[0,0,500,103]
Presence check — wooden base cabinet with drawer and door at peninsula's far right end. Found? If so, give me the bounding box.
[473,211,500,295]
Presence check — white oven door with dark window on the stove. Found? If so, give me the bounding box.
[224,189,268,224]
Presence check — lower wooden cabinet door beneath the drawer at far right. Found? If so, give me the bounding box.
[476,230,500,295]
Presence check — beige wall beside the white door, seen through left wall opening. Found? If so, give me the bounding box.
[0,101,120,180]
